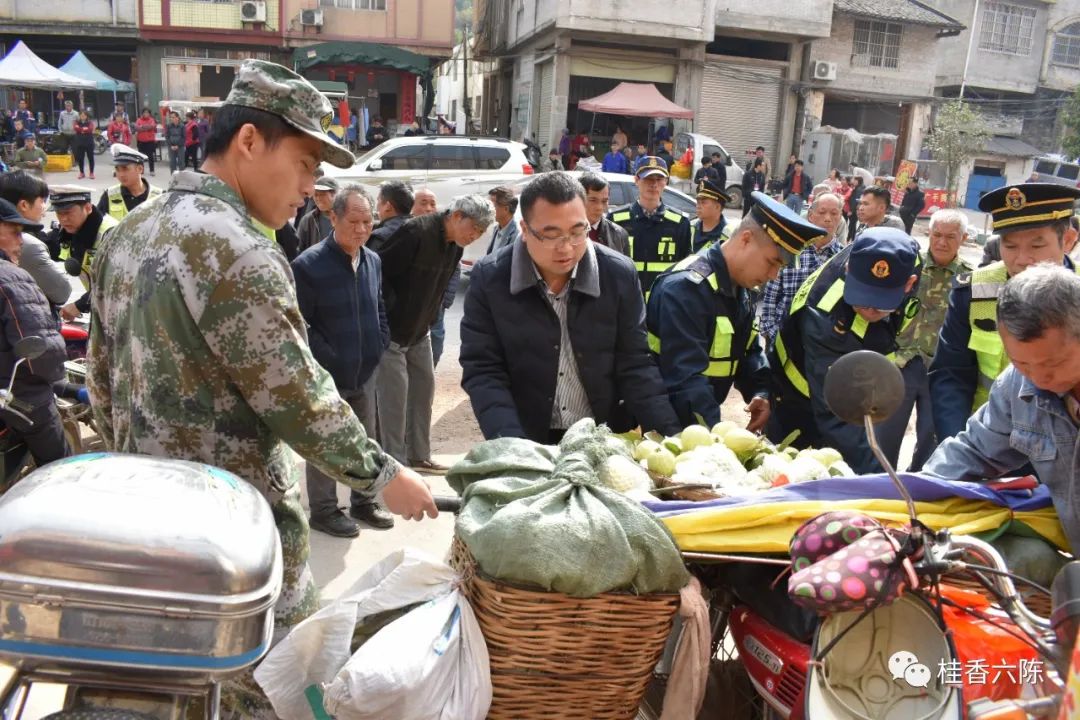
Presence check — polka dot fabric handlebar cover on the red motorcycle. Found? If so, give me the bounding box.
[787,511,919,614]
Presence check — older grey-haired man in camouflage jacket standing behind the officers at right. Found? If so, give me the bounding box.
[877,209,972,472]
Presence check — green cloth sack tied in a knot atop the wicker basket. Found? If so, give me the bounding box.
[456,446,689,598]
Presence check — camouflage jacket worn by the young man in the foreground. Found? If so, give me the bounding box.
[86,172,399,504]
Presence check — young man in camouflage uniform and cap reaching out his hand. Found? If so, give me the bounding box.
[87,60,437,717]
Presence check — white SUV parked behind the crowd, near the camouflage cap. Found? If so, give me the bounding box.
[323,135,534,207]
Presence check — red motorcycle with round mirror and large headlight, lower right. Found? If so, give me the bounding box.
[649,353,1080,720]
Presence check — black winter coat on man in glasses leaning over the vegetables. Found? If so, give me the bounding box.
[461,243,679,443]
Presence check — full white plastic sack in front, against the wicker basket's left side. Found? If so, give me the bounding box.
[324,590,491,720]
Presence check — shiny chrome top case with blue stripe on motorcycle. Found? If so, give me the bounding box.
[0,453,282,679]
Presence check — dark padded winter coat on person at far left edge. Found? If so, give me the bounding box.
[0,253,67,410]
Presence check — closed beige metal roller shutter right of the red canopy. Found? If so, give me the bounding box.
[694,56,784,167]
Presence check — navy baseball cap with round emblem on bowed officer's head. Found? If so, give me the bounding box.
[843,227,919,311]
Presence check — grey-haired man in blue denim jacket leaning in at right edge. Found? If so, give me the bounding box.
[923,263,1080,552]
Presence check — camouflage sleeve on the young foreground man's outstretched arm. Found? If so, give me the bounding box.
[199,248,400,490]
